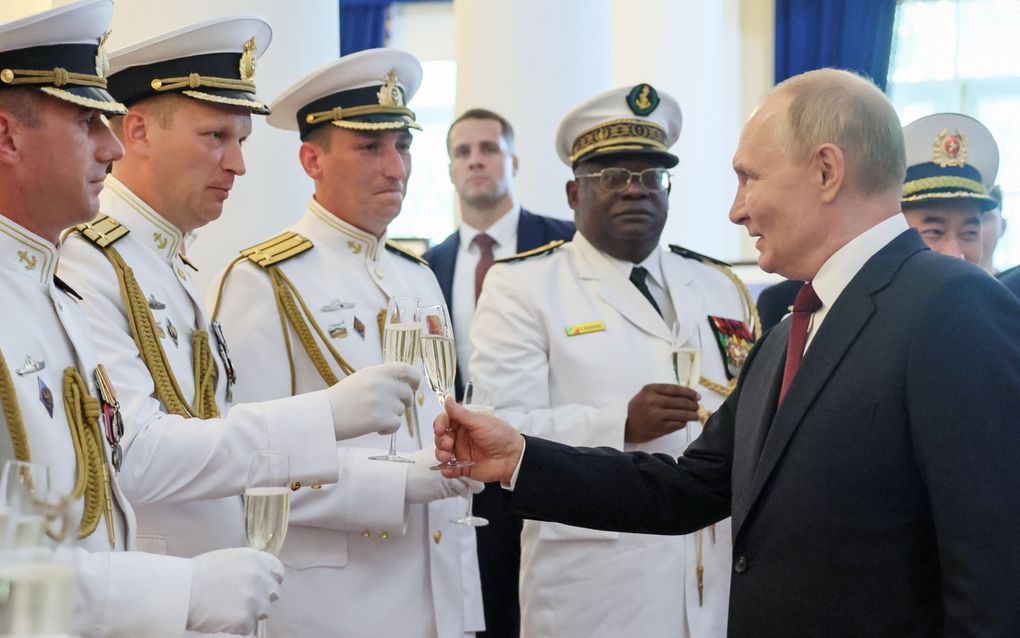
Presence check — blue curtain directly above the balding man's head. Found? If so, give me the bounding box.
[775,0,896,91]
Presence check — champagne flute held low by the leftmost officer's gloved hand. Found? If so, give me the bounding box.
[239,450,291,638]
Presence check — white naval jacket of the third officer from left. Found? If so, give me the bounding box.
[210,199,482,638]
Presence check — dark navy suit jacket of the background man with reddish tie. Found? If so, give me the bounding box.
[424,208,574,638]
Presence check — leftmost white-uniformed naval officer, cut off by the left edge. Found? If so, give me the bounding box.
[0,0,293,637]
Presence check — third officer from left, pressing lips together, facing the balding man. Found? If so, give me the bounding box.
[213,49,482,638]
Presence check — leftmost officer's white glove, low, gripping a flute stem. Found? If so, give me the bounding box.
[188,547,284,636]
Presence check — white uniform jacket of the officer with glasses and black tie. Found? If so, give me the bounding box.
[471,233,744,638]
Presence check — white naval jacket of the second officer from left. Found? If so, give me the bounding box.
[59,177,338,556]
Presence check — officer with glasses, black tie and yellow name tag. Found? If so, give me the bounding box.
[470,84,754,638]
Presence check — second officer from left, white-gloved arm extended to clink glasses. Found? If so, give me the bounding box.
[54,16,426,632]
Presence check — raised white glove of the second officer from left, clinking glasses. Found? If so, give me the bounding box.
[325,363,421,441]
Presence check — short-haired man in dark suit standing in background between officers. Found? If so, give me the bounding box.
[424,108,574,638]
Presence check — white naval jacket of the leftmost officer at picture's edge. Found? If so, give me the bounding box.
[0,216,191,638]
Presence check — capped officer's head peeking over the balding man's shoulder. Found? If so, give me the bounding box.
[903,113,999,263]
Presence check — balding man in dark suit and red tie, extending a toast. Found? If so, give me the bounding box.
[436,69,1020,637]
